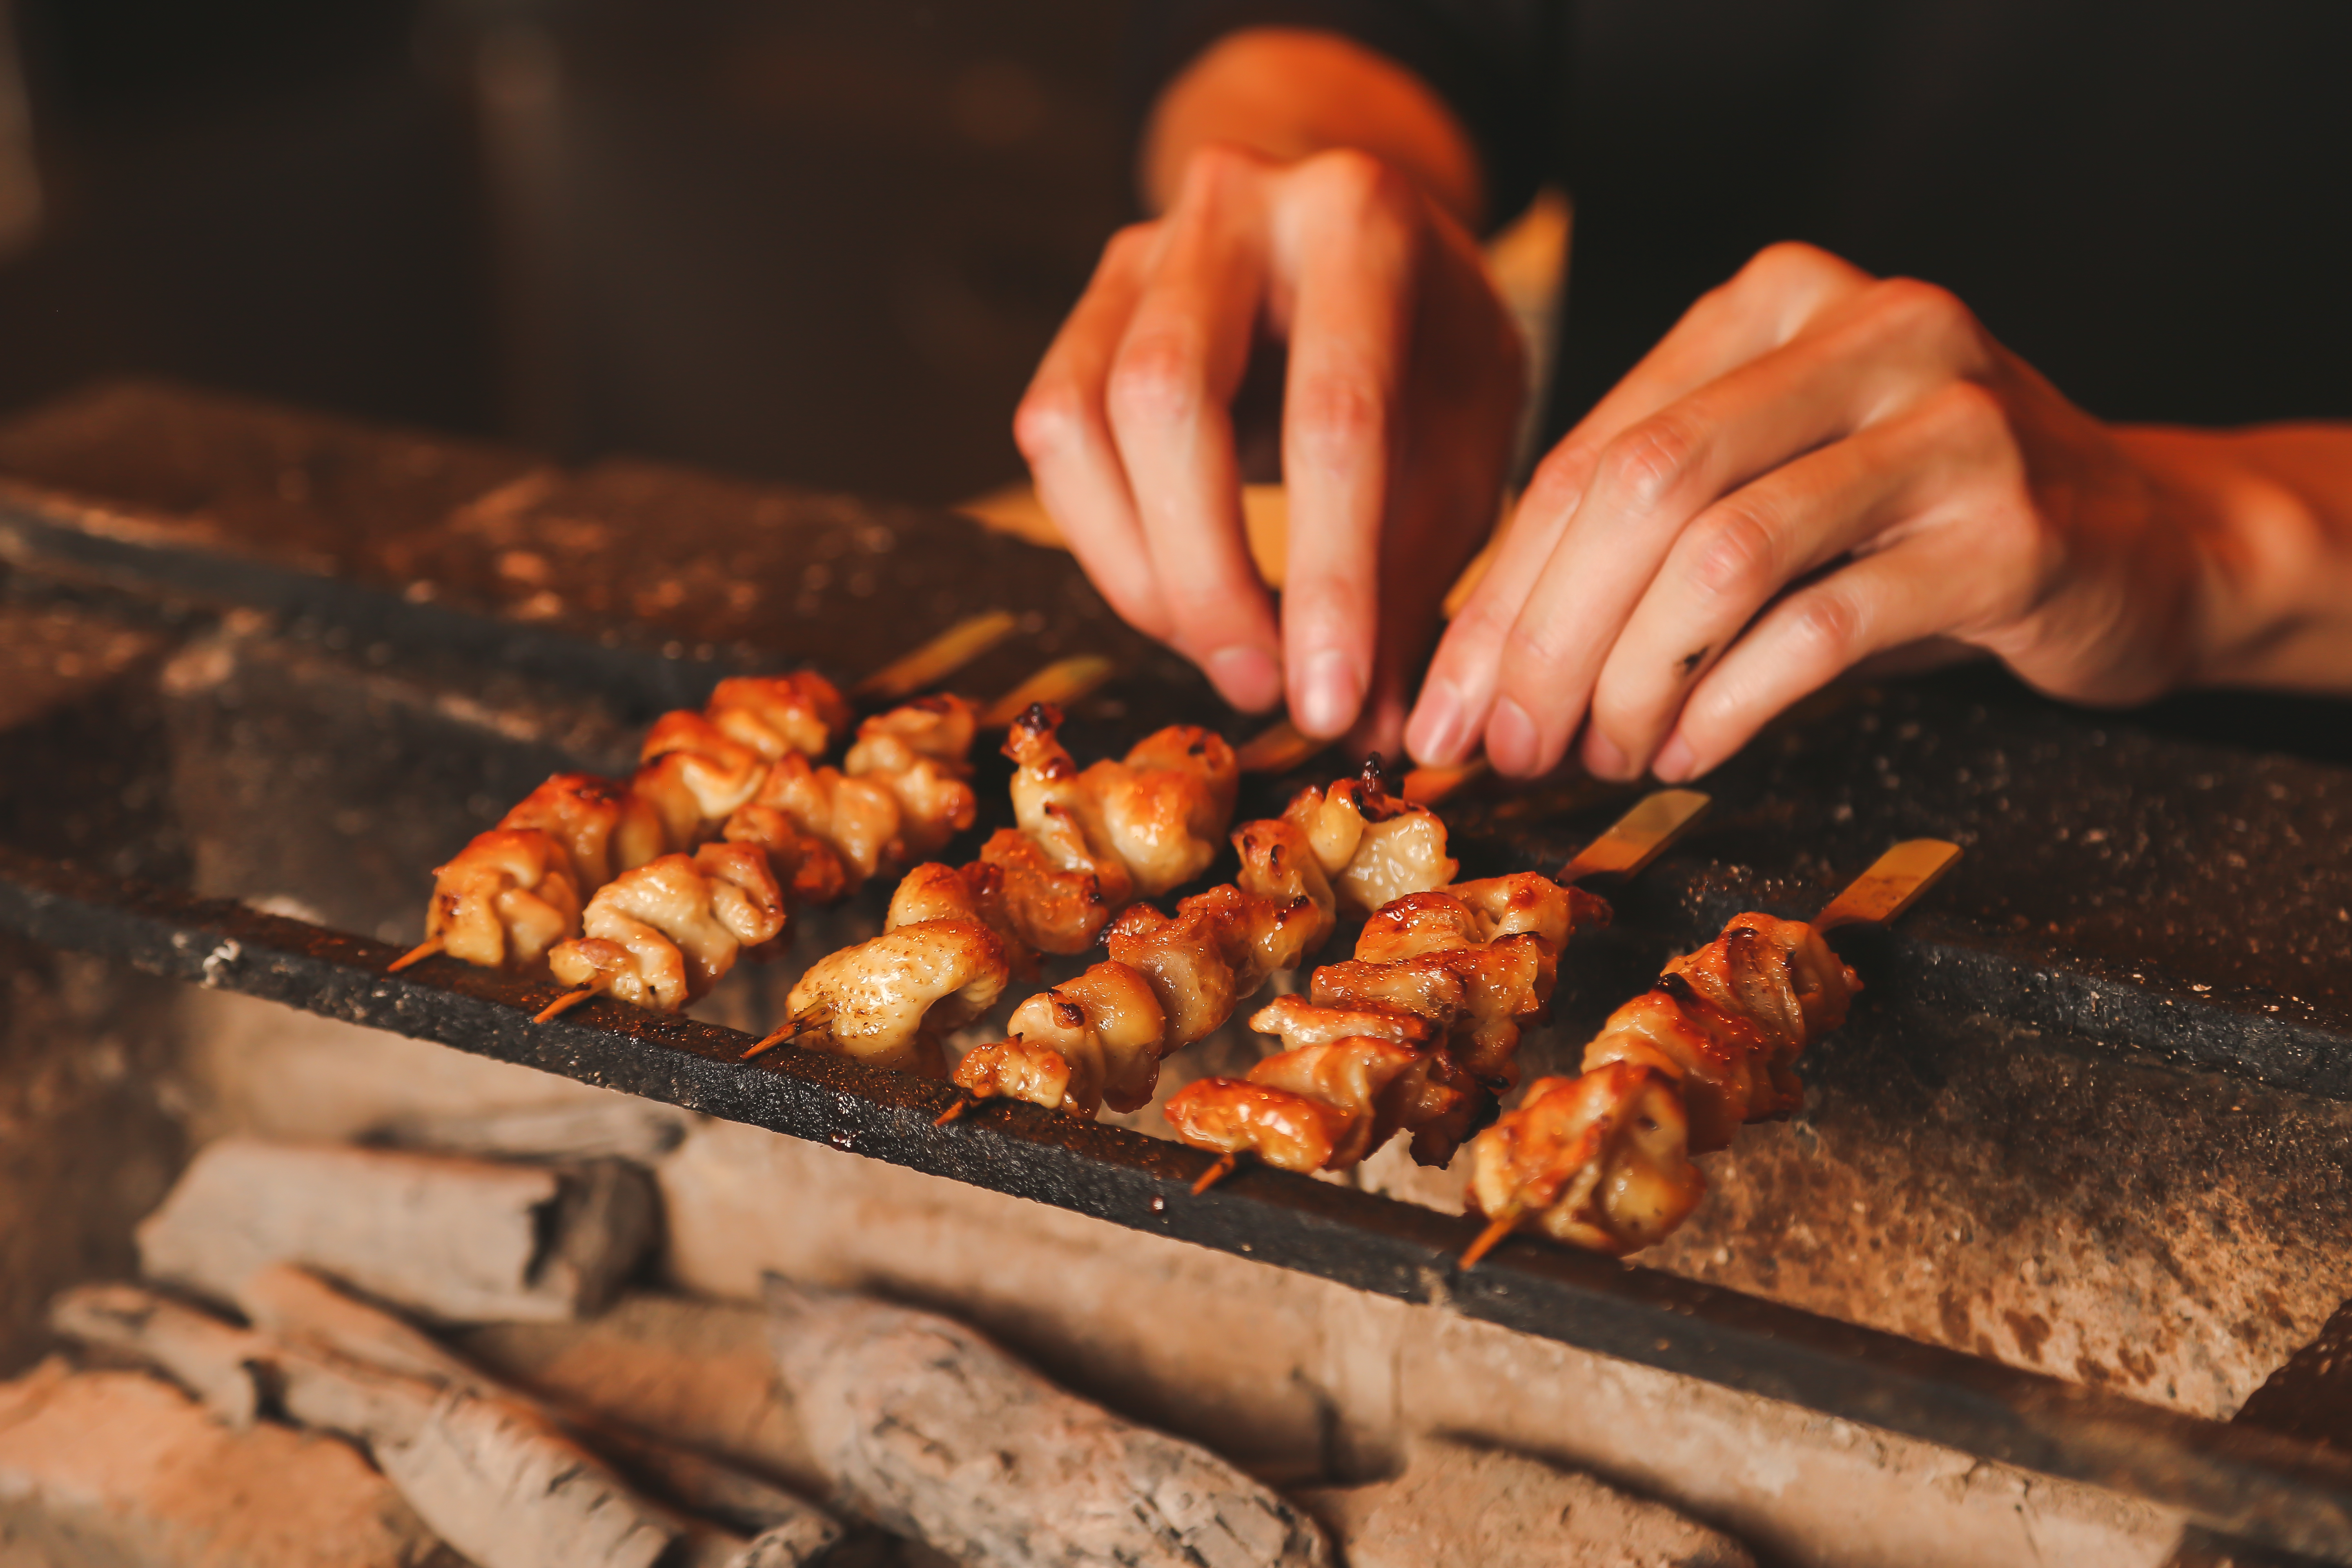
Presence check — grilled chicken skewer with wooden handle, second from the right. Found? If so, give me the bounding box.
[1167,790,1708,1189]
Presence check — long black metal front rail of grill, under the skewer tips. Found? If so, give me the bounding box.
[0,849,2352,1563]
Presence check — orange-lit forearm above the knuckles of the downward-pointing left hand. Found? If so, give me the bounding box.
[1136,28,1486,233]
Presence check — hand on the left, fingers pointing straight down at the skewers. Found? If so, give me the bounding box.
[1014,146,1526,750]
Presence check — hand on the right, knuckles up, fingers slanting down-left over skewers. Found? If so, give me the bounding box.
[1406,245,2223,780]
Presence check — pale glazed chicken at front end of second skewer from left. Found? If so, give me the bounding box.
[548,844,786,1013]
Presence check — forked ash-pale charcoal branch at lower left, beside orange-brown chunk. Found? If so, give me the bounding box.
[54,1265,842,1568]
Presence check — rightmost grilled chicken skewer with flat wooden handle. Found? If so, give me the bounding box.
[1463,839,1959,1267]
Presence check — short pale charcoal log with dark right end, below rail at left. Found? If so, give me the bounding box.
[139,1138,656,1321]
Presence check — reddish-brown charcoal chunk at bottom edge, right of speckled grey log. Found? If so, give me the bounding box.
[1298,1439,1755,1568]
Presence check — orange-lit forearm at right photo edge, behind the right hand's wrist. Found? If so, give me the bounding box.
[2119,423,2352,691]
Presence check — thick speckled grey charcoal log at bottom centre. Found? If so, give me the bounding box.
[769,1276,1331,1568]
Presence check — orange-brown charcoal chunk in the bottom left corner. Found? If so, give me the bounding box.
[0,1359,466,1568]
